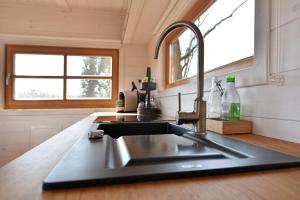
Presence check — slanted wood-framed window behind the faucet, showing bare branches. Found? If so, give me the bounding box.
[166,0,255,87]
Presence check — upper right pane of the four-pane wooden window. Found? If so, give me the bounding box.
[67,56,112,76]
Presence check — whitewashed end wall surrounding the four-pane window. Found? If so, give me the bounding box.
[0,6,148,166]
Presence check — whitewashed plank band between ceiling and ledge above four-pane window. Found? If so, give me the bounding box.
[0,5,123,41]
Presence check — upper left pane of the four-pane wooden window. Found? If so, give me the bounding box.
[14,53,64,76]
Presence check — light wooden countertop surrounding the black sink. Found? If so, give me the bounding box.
[0,113,300,200]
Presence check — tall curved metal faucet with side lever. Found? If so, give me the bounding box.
[154,21,206,136]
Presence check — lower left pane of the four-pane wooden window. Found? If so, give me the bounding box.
[14,78,63,100]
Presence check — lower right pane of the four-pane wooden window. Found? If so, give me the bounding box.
[67,79,112,99]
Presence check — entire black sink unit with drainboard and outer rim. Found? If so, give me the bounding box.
[43,121,300,189]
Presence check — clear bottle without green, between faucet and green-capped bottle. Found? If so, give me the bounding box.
[207,77,222,118]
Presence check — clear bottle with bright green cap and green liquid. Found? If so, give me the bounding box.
[221,75,240,121]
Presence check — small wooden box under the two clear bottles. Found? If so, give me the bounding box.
[206,118,252,135]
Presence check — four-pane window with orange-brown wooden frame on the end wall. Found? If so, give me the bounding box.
[5,45,118,108]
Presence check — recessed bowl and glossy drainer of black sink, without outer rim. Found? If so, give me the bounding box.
[98,122,248,169]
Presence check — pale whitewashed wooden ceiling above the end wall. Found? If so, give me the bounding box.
[0,0,173,44]
